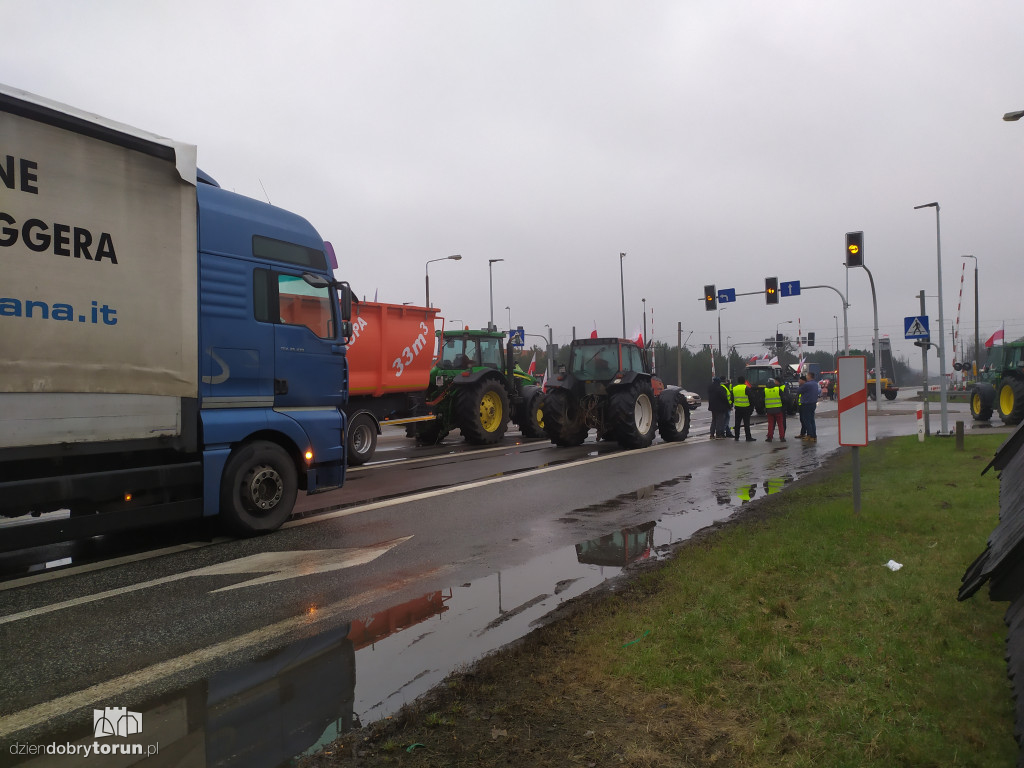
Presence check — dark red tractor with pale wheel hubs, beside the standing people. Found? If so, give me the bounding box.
[543,339,690,449]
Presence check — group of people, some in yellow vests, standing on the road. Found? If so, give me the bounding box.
[708,374,821,442]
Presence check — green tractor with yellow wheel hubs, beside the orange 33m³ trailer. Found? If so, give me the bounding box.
[416,330,545,445]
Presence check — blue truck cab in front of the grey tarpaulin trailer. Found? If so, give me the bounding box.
[197,173,351,534]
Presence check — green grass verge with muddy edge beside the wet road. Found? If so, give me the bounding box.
[303,435,1017,768]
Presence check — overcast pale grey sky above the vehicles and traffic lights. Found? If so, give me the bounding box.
[0,0,1024,371]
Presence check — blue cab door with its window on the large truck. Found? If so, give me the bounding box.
[270,272,348,408]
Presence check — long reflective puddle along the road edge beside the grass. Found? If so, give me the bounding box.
[9,452,827,768]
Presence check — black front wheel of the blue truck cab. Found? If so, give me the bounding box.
[220,440,298,536]
